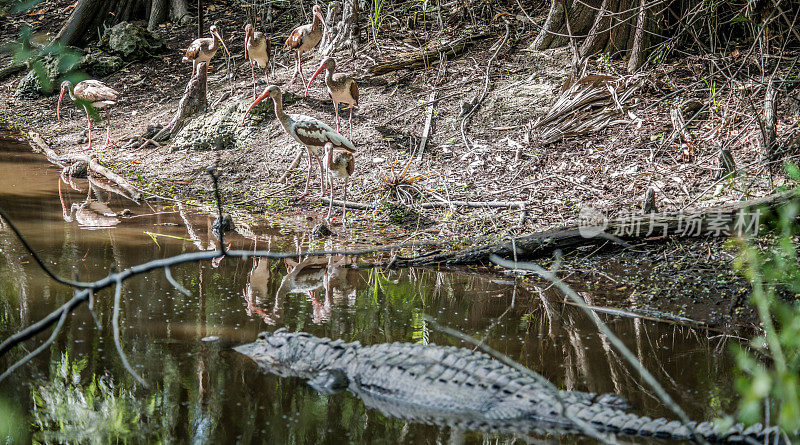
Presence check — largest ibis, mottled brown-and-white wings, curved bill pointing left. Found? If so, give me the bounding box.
[242,85,356,199]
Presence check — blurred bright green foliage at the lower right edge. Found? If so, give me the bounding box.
[735,174,800,432]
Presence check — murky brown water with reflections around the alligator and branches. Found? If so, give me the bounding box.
[0,134,735,443]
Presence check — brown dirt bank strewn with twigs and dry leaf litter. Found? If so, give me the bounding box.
[0,1,793,328]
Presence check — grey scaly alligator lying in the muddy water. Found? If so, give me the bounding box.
[234,328,782,443]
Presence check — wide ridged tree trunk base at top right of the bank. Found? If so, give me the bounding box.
[532,0,655,71]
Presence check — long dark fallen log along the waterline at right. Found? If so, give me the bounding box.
[394,190,800,267]
